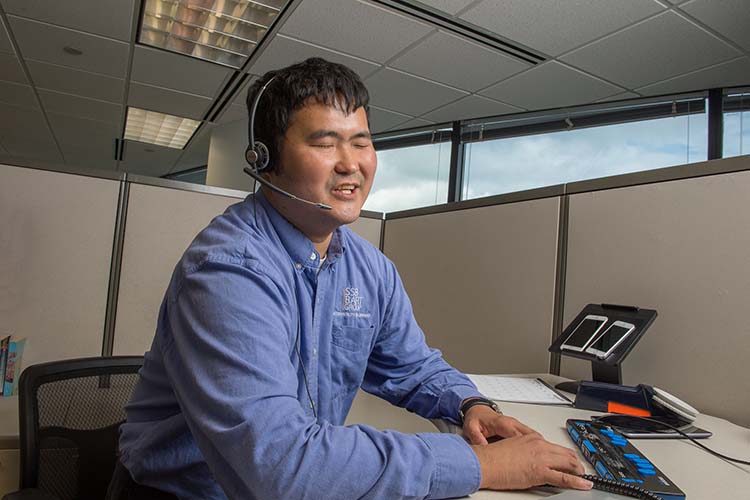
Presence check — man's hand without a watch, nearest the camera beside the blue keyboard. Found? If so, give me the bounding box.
[471,432,592,490]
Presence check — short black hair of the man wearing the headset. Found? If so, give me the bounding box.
[246,57,370,171]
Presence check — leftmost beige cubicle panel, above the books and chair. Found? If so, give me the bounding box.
[0,165,120,366]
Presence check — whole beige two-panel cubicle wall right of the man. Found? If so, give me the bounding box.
[384,156,750,426]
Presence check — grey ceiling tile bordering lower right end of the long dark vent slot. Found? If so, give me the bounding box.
[390,31,531,91]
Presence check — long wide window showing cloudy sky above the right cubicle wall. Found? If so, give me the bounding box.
[462,97,708,199]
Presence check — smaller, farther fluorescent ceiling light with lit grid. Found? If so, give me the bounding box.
[125,107,201,149]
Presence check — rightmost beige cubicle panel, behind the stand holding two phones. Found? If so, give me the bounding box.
[560,163,750,426]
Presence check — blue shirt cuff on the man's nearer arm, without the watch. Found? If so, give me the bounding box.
[417,433,482,498]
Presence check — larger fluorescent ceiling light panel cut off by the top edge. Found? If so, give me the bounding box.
[138,0,287,68]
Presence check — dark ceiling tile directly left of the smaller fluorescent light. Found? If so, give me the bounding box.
[47,113,120,162]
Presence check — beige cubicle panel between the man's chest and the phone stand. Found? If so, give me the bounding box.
[384,197,560,373]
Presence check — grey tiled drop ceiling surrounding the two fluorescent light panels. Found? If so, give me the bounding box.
[0,0,750,176]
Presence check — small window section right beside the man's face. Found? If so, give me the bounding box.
[363,142,451,212]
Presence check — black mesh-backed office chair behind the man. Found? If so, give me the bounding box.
[3,356,143,500]
